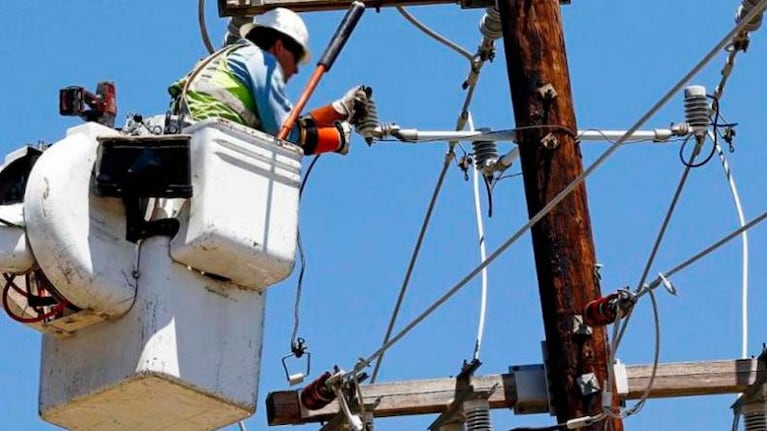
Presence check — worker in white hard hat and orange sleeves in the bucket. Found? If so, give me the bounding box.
[168,8,367,154]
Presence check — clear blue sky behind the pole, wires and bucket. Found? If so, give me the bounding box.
[0,0,767,431]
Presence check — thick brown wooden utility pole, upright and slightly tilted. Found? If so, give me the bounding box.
[499,0,623,431]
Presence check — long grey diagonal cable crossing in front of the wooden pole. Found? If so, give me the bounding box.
[354,0,767,372]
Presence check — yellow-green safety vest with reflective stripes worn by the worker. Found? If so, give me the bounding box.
[168,43,261,129]
